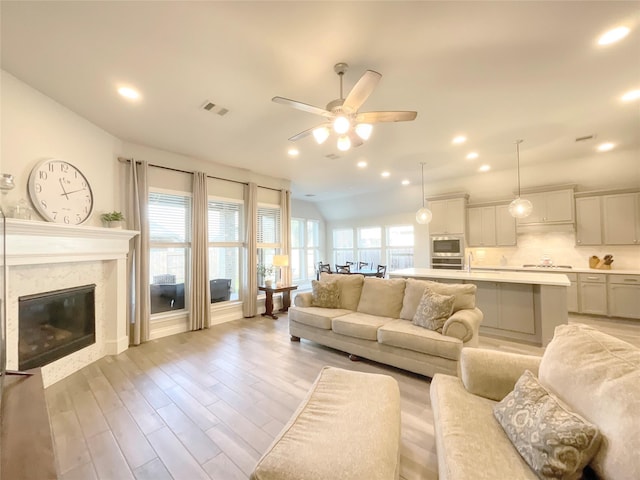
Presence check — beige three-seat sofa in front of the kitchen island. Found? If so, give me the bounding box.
[289,273,482,377]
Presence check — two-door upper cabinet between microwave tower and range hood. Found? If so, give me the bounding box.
[467,205,516,247]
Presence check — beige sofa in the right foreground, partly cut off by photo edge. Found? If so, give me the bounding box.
[430,325,640,480]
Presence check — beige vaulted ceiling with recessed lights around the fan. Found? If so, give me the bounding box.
[1,1,640,201]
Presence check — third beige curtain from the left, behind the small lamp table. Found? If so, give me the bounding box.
[242,182,258,317]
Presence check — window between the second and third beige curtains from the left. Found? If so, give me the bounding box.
[208,198,243,303]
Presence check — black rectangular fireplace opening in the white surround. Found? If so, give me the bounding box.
[18,284,96,370]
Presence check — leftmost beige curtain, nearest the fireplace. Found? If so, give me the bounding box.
[126,159,151,345]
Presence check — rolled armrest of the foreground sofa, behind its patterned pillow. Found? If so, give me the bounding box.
[459,348,542,401]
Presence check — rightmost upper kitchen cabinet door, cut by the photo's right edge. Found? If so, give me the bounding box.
[602,193,640,245]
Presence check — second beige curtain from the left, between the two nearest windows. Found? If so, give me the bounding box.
[189,172,211,330]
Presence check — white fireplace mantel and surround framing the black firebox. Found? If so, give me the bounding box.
[5,218,139,386]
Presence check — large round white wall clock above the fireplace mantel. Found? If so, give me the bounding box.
[27,159,93,225]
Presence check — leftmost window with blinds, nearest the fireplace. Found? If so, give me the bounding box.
[149,191,191,314]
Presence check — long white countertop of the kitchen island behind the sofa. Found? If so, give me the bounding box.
[389,268,571,287]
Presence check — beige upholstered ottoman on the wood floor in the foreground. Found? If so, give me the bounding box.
[251,367,400,480]
